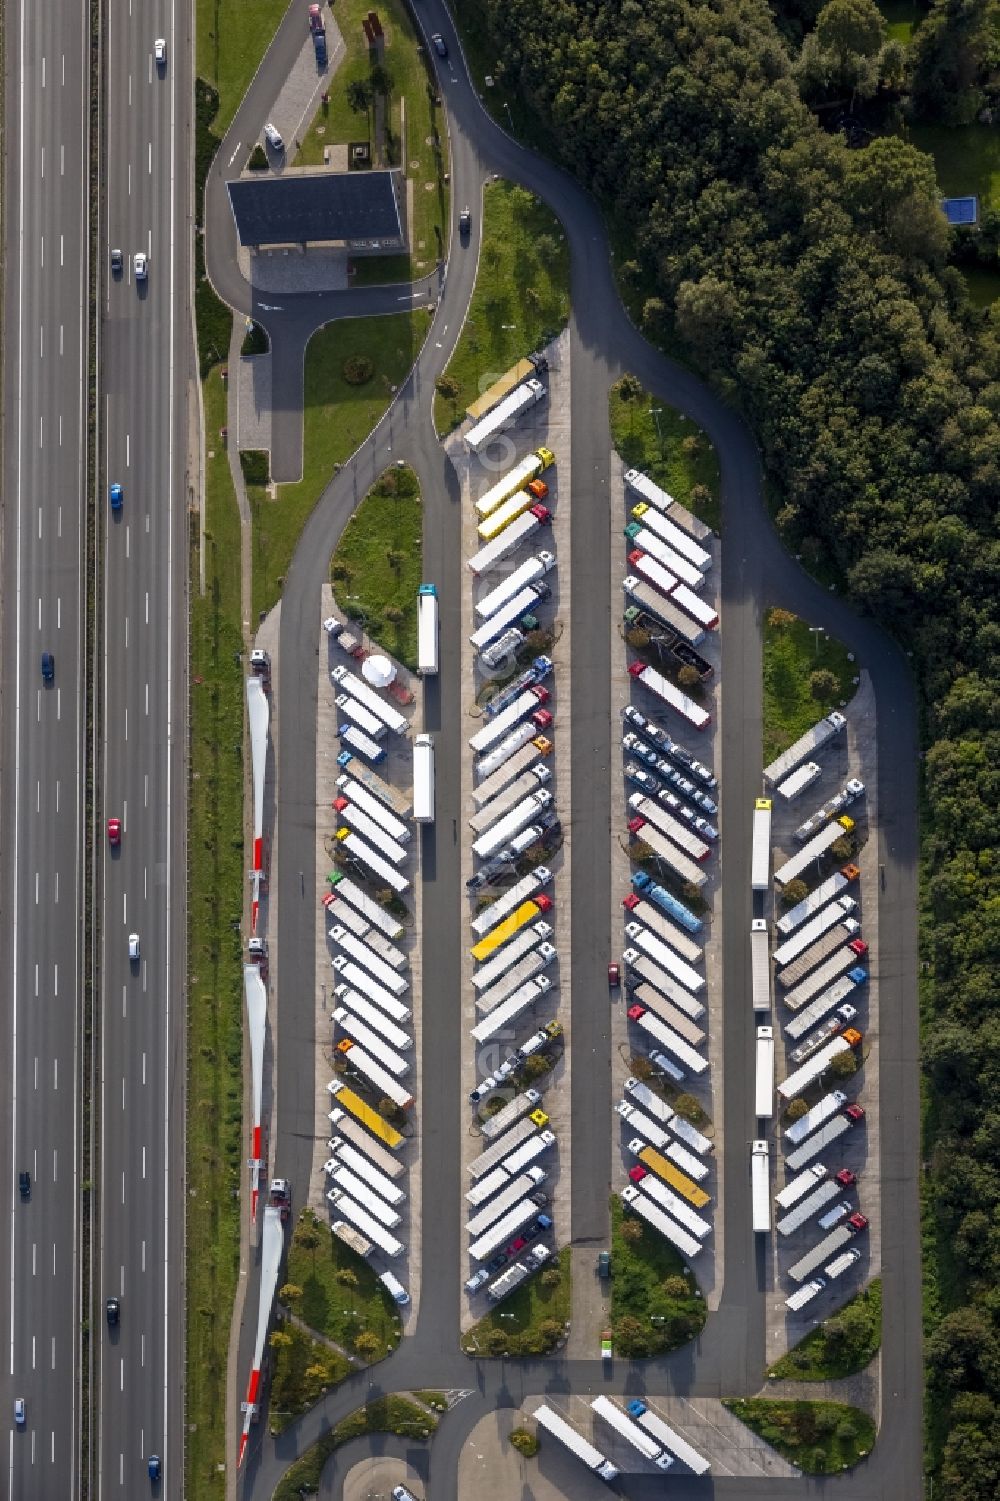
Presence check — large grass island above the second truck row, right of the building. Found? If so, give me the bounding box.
[434,182,569,432]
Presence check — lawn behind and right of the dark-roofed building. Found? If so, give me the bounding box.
[294,0,450,285]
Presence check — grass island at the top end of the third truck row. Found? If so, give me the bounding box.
[608,375,722,531]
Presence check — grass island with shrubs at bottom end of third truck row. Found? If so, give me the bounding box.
[611,1193,706,1357]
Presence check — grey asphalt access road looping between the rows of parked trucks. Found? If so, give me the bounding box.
[220,0,922,1501]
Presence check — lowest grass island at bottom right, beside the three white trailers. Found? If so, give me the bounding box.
[722,1397,875,1475]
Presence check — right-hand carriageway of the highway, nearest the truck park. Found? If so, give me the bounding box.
[95,0,191,1498]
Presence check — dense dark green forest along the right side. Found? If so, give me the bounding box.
[483,0,1000,1482]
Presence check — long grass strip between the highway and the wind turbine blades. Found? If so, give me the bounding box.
[185,371,243,1501]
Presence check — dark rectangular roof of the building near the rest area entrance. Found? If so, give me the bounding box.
[227,171,402,245]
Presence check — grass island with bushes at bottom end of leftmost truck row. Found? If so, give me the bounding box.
[285,1210,399,1360]
